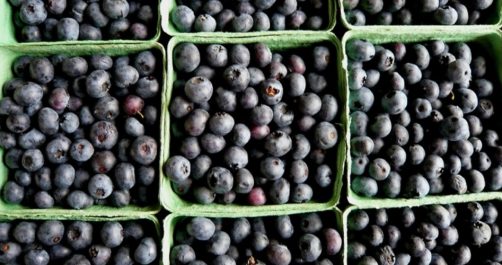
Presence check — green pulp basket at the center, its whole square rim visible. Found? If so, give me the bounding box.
[160,33,348,217]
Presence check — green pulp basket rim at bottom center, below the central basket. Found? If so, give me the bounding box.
[162,208,346,265]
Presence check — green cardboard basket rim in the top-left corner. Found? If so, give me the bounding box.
[0,0,161,46]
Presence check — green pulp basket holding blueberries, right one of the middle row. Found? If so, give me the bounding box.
[342,27,502,207]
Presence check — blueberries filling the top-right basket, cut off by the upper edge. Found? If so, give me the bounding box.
[343,0,497,26]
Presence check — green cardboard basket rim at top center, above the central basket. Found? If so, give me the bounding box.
[160,0,337,38]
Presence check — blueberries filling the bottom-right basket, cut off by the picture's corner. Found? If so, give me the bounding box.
[347,202,502,265]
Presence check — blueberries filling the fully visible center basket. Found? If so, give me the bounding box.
[164,43,343,205]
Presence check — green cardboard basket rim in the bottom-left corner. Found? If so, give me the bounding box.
[0,213,163,265]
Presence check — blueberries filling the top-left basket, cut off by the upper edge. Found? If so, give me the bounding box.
[9,0,158,42]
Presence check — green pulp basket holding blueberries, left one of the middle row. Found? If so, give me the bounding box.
[0,42,166,218]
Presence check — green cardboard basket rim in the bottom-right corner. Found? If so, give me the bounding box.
[344,197,502,265]
